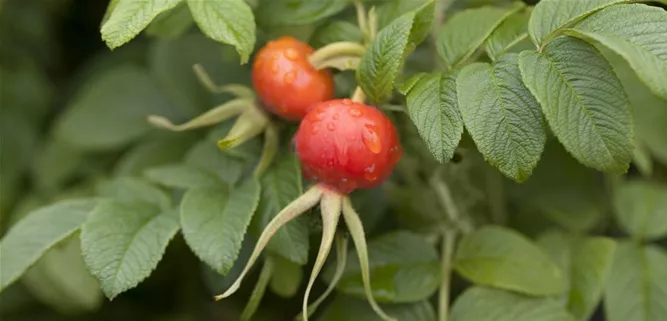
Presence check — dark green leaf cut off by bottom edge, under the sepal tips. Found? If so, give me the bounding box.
[318,296,437,321]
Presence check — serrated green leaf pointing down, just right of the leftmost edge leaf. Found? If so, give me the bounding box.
[81,201,179,299]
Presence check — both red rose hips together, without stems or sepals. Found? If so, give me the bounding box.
[252,37,402,194]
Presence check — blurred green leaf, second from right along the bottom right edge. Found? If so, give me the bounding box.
[537,231,616,321]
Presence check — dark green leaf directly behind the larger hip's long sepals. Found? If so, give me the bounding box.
[324,231,440,303]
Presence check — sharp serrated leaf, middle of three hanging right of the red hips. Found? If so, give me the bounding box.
[456,54,547,182]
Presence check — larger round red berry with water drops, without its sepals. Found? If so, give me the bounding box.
[295,99,403,194]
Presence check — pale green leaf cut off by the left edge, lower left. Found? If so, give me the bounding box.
[0,199,97,291]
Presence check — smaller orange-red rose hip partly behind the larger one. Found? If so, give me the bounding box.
[252,37,334,121]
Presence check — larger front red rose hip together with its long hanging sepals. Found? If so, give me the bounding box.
[216,100,402,321]
